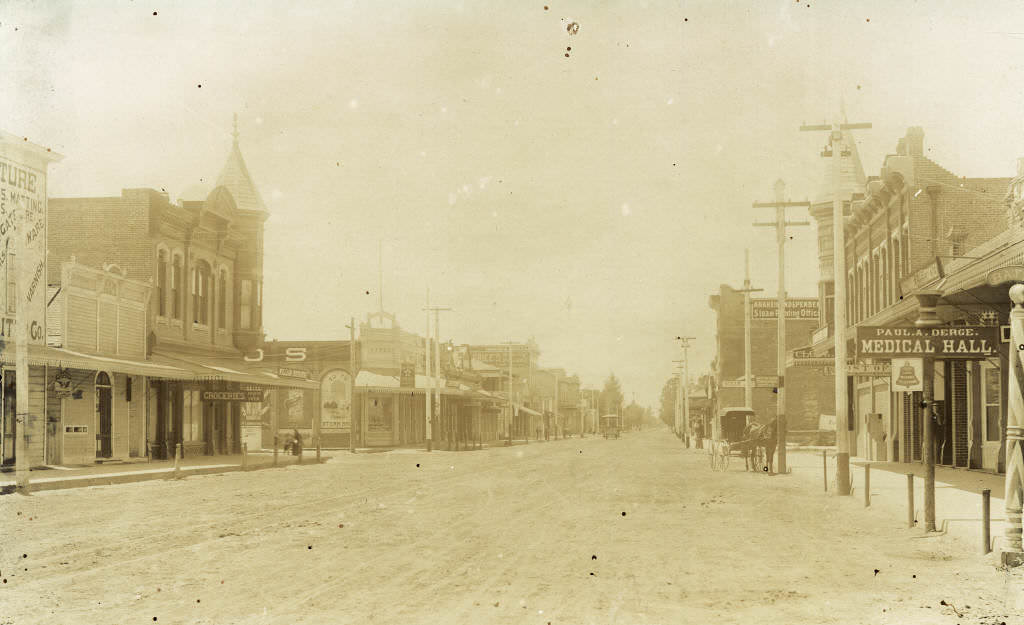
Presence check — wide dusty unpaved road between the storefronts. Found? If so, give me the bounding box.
[0,429,1024,625]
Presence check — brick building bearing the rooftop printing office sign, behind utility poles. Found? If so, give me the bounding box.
[709,285,835,441]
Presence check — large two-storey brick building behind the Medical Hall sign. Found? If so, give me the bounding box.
[810,127,1020,469]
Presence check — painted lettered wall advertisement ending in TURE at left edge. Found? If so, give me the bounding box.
[0,155,46,344]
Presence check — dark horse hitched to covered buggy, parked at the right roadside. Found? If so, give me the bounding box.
[708,408,777,471]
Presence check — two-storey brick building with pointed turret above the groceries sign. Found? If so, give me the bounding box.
[47,121,316,457]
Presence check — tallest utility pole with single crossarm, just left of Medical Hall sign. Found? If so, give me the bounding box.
[800,114,871,496]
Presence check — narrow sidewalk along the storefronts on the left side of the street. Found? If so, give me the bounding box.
[0,450,331,494]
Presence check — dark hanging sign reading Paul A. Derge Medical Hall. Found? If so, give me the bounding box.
[857,326,999,360]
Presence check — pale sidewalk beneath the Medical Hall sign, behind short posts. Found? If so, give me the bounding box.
[787,449,1006,553]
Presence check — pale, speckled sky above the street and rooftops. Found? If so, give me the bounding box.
[6,0,1024,407]
